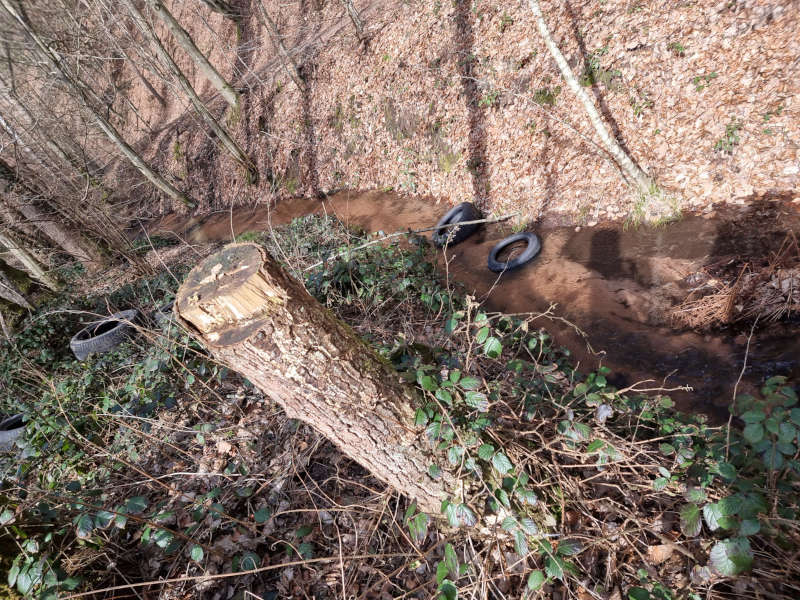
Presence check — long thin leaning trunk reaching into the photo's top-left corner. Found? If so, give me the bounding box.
[0,0,192,206]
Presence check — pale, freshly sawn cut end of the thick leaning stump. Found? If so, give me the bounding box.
[174,244,287,346]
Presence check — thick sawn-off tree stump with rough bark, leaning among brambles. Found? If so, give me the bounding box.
[174,244,456,513]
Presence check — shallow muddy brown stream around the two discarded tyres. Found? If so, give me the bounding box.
[148,191,800,420]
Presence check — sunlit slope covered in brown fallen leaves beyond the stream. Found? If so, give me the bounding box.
[119,0,800,224]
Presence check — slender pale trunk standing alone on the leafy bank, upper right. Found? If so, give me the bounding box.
[528,0,653,193]
